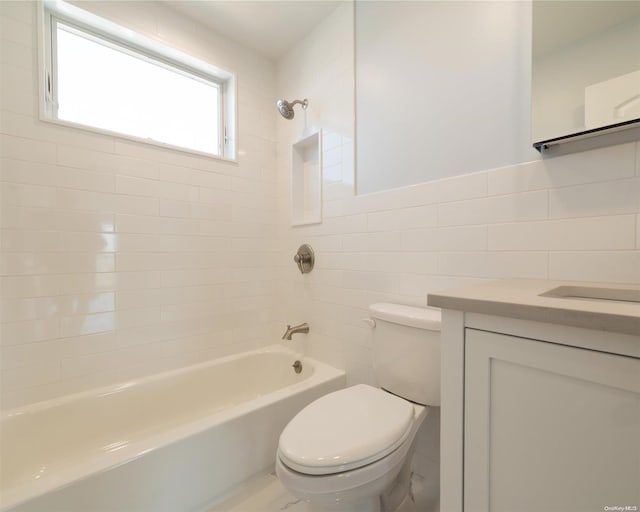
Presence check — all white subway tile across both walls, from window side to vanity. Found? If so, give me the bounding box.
[0,2,640,490]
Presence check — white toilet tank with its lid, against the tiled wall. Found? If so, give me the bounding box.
[369,303,441,406]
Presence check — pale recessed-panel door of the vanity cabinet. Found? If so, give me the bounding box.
[464,329,640,512]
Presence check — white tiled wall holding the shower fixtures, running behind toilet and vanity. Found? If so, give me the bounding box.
[277,0,640,501]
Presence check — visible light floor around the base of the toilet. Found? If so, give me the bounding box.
[209,473,438,512]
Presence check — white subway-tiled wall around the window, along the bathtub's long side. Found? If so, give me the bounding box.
[0,1,279,408]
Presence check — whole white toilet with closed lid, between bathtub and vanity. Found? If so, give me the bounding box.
[276,303,441,512]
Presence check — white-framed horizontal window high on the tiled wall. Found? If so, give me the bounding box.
[43,1,235,159]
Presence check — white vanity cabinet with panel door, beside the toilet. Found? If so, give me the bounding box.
[429,283,640,512]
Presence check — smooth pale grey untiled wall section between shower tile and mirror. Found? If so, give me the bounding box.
[355,0,540,195]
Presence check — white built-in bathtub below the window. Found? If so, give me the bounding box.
[0,345,345,512]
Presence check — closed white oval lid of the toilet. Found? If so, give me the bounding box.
[278,384,414,475]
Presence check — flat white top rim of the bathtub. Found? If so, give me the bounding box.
[0,344,345,512]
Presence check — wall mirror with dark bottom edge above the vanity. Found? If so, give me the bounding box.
[531,0,640,149]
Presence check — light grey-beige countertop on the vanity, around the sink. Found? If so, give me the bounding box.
[427,279,640,336]
